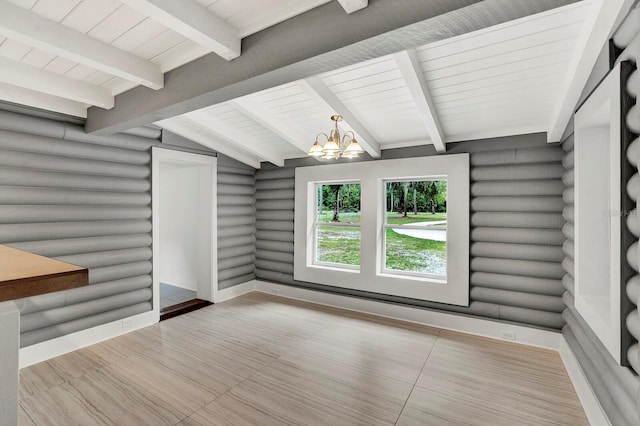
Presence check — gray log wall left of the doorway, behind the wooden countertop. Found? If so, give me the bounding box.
[0,112,157,346]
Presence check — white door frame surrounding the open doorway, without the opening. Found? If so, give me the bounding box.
[151,147,218,321]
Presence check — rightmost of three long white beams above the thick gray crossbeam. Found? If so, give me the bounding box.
[121,0,241,61]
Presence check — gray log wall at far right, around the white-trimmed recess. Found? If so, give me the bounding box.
[562,5,640,426]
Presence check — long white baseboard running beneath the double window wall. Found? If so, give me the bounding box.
[255,280,562,351]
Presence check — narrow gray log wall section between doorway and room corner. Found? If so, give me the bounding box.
[218,154,256,290]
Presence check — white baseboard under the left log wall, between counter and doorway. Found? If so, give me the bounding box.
[20,311,158,368]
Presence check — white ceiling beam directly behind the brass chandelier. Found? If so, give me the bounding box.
[296,77,382,158]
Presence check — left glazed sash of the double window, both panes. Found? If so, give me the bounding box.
[315,182,360,268]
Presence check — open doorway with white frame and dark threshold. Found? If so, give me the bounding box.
[152,147,218,320]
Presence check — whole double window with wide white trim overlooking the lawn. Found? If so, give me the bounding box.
[294,154,469,306]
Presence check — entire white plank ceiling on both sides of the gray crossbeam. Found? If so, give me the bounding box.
[0,0,620,167]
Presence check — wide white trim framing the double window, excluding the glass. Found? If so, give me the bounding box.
[294,154,469,306]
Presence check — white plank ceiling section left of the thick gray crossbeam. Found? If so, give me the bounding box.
[0,0,338,117]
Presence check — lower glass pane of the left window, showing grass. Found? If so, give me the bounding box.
[316,225,360,266]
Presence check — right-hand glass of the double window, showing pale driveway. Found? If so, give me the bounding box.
[385,179,447,277]
